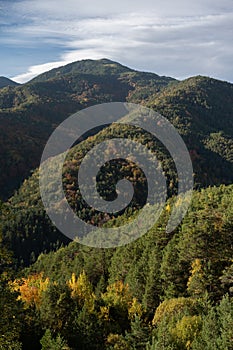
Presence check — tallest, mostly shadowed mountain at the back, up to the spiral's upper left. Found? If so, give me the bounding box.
[0,59,176,198]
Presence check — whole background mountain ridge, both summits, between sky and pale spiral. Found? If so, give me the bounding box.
[0,59,233,199]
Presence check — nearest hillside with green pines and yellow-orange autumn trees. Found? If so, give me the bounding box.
[0,185,233,350]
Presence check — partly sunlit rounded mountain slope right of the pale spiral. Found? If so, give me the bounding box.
[148,76,233,185]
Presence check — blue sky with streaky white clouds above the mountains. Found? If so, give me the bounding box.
[0,0,233,83]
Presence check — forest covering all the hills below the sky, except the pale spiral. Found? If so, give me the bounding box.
[0,59,233,350]
